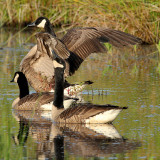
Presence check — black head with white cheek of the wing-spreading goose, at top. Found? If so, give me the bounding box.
[27,17,50,28]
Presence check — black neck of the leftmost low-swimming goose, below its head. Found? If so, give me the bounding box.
[18,80,29,99]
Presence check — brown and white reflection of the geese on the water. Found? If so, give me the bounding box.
[13,110,141,160]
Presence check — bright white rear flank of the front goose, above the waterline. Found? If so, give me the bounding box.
[86,109,122,123]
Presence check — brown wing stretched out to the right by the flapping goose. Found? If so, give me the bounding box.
[61,27,142,75]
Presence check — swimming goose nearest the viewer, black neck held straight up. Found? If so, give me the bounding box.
[48,52,127,123]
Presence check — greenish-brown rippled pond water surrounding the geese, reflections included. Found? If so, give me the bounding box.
[0,29,160,160]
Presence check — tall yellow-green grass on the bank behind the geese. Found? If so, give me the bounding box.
[0,0,160,43]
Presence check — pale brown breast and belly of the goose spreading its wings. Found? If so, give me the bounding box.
[20,45,55,92]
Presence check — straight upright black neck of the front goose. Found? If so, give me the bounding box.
[53,68,64,108]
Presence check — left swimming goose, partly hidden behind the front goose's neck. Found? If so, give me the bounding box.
[11,72,78,110]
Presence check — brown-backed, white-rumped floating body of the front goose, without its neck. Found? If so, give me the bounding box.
[52,103,127,124]
